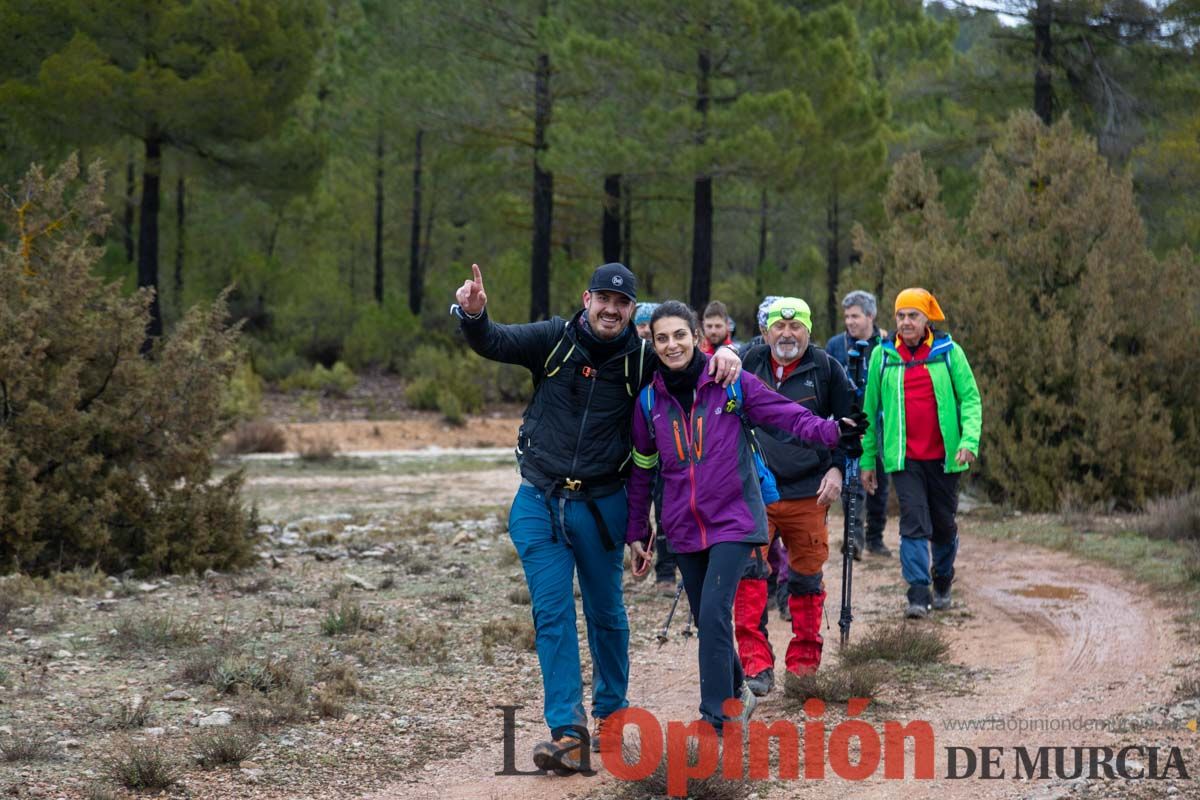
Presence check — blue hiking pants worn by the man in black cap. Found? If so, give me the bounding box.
[509,483,629,739]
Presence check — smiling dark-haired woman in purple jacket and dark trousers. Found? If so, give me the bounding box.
[625,300,865,733]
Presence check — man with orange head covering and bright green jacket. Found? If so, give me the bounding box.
[859,289,983,619]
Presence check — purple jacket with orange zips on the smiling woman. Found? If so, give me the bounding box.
[625,359,839,553]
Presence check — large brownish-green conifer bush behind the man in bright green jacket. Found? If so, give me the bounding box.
[859,112,1200,510]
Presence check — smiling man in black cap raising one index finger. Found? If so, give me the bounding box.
[451,264,742,771]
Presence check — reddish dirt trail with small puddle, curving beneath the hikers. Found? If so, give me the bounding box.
[370,519,1183,800]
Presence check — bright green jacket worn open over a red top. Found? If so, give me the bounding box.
[859,331,983,473]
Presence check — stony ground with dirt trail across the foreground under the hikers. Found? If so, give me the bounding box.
[0,393,1200,800]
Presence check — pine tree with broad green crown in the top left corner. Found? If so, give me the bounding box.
[0,0,322,337]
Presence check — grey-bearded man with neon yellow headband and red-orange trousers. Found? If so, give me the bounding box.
[734,297,854,694]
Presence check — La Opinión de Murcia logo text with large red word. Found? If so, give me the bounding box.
[493,698,1190,796]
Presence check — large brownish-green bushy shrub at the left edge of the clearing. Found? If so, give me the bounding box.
[0,158,256,575]
